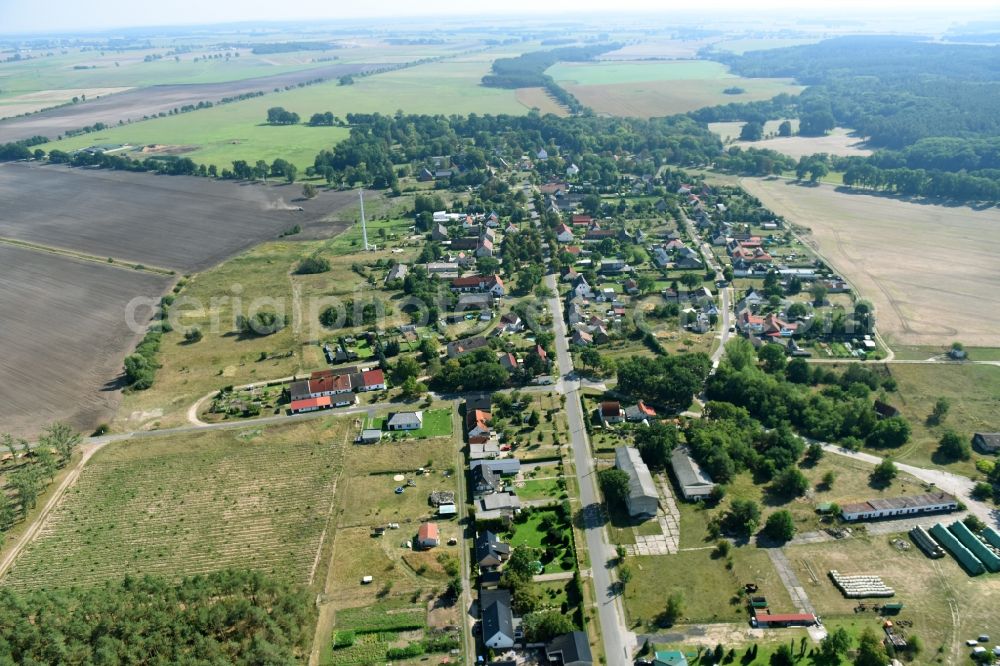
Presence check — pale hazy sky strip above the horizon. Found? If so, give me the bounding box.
[0,0,998,34]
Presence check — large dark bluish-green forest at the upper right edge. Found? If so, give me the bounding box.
[704,37,1000,201]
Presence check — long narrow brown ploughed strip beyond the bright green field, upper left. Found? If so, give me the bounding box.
[0,63,382,143]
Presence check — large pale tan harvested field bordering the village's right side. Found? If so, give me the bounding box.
[741,178,1000,346]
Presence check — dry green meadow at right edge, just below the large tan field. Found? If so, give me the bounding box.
[887,364,1000,476]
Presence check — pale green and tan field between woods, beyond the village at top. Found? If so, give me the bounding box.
[547,60,801,118]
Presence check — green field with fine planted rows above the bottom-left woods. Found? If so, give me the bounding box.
[2,419,347,588]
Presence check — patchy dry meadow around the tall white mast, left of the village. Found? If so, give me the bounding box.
[115,194,426,430]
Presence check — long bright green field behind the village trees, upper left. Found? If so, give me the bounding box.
[46,59,528,171]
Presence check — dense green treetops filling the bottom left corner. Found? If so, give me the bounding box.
[0,571,315,664]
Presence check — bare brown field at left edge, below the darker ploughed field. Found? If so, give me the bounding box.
[0,244,170,436]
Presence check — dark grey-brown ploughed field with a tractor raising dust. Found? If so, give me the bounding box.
[0,163,357,272]
